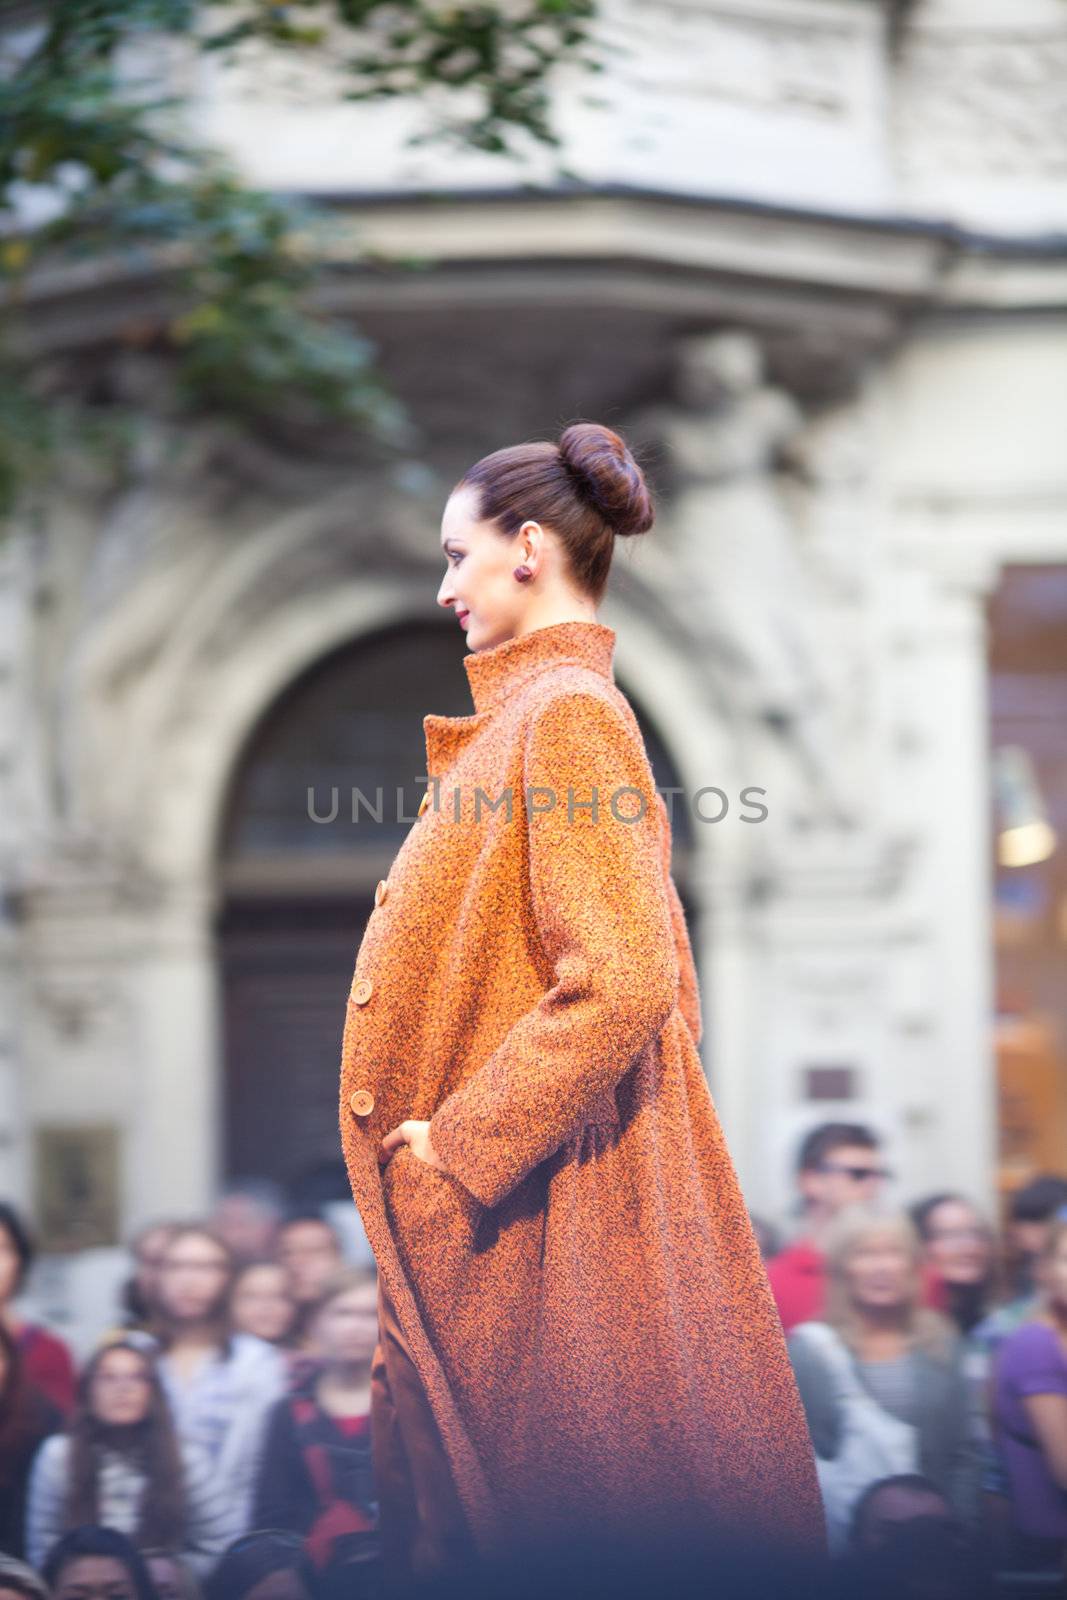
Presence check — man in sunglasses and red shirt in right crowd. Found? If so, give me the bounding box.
[766,1122,889,1333]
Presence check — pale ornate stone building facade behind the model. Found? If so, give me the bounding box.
[0,0,1067,1248]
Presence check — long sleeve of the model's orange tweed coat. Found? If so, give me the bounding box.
[430,693,678,1206]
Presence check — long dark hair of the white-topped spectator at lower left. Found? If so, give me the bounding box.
[62,1339,187,1546]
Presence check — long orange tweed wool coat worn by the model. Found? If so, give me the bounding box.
[341,621,824,1554]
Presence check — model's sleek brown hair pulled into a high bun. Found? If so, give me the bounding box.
[453,422,656,600]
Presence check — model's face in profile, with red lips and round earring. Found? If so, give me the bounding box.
[437,485,557,650]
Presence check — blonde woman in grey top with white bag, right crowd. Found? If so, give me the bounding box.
[789,1208,977,1549]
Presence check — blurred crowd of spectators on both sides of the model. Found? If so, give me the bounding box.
[0,1123,1067,1600]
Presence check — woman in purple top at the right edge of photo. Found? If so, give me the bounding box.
[993,1221,1067,1568]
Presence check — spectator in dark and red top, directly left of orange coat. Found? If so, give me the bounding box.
[254,1267,378,1570]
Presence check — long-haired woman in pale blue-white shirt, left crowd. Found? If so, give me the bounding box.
[150,1222,288,1531]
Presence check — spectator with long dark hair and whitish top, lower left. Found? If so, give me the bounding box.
[26,1341,232,1573]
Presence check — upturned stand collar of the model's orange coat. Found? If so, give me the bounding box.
[422,621,614,778]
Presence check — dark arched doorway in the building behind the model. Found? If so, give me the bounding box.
[216,621,696,1202]
